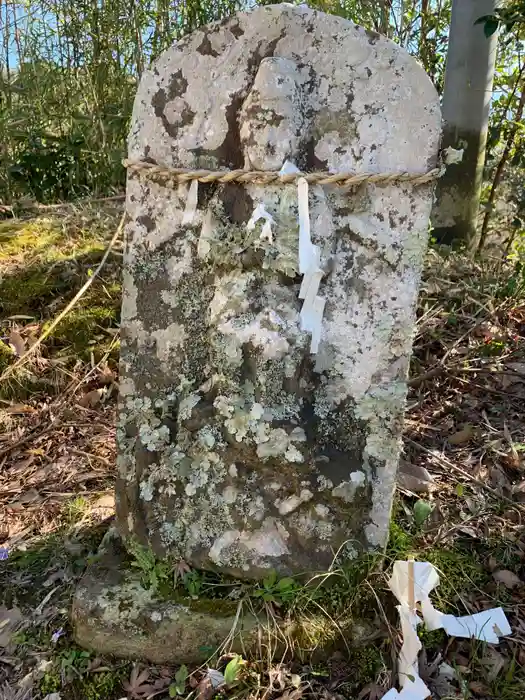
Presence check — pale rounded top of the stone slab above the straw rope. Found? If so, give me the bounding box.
[129,4,441,178]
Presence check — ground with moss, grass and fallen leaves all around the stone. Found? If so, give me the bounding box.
[0,215,525,700]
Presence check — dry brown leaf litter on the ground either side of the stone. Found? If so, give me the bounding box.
[0,217,525,700]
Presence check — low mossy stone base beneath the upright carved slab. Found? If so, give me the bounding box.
[72,530,377,664]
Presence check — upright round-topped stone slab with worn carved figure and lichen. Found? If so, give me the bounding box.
[117,4,440,577]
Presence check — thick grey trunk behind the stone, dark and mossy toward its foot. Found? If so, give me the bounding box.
[432,0,497,248]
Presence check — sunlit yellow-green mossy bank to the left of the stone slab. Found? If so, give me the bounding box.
[0,209,121,399]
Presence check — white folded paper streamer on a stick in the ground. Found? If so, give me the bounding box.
[383,561,511,700]
